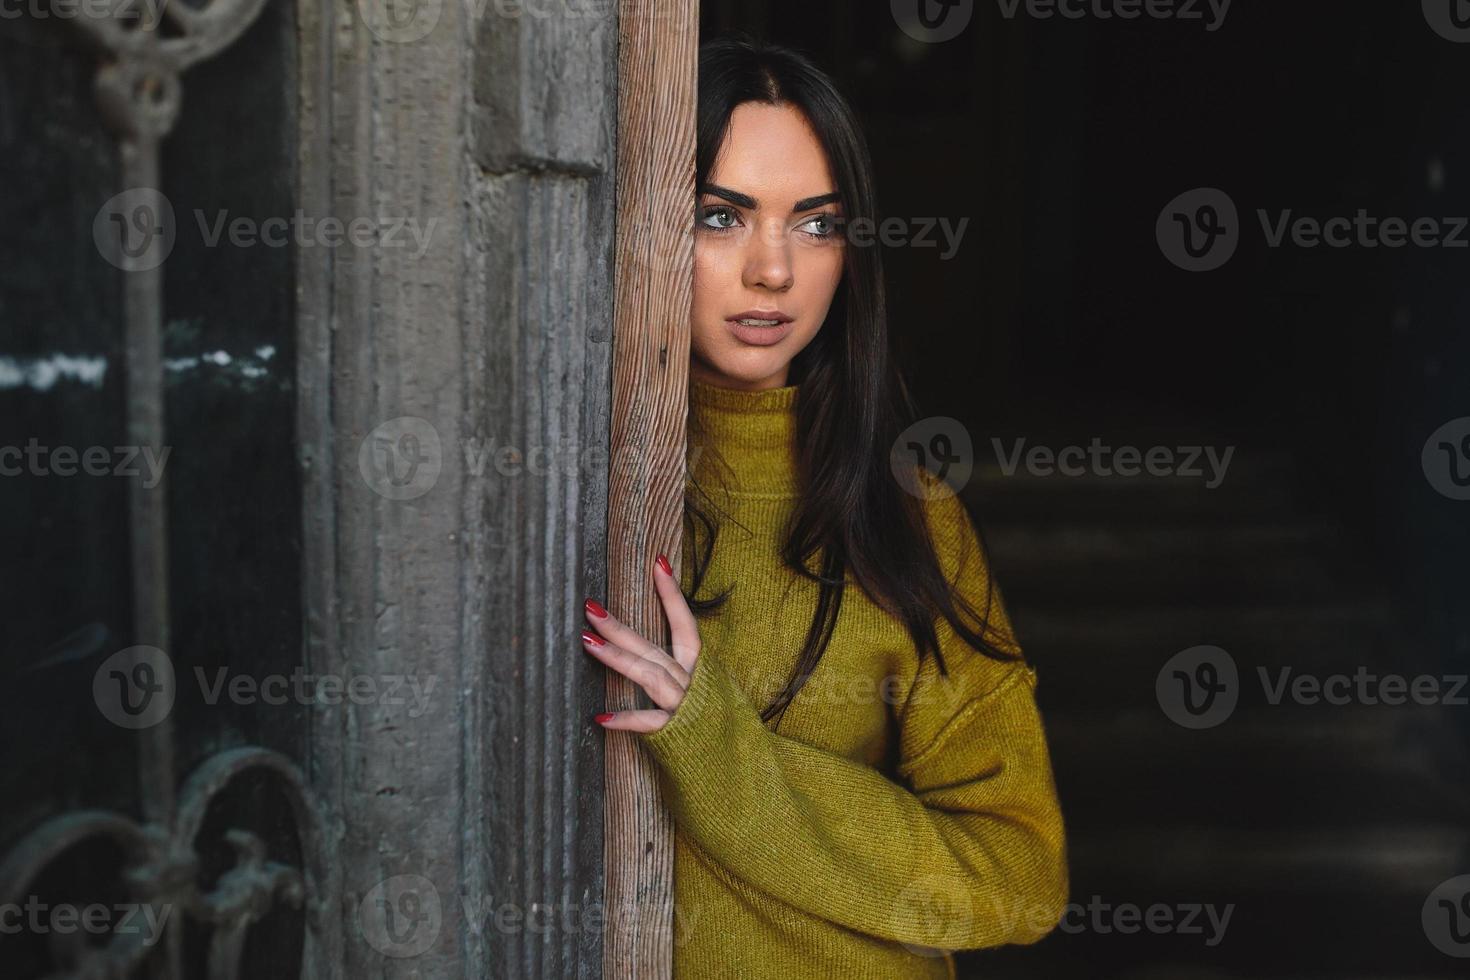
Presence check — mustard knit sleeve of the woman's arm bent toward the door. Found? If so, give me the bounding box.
[641,487,1069,949]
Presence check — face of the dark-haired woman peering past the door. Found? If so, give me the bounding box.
[689,103,845,391]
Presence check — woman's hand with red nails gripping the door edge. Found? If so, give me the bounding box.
[582,555,700,732]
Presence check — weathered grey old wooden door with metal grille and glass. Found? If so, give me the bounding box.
[0,0,705,980]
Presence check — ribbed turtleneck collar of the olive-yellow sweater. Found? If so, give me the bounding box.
[688,378,800,497]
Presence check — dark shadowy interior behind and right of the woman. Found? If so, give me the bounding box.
[701,0,1470,977]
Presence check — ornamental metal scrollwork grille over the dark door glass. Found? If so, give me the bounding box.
[0,0,325,980]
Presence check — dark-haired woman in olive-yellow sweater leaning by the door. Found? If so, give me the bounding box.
[582,40,1067,979]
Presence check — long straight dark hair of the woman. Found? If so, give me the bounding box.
[684,35,1016,724]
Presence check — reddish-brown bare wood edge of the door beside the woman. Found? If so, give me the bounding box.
[603,0,698,979]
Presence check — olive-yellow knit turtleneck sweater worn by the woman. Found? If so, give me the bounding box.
[638,382,1069,980]
